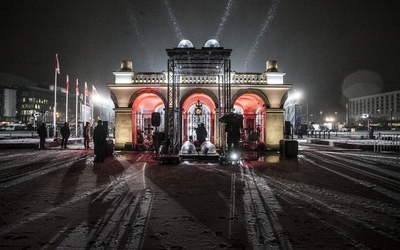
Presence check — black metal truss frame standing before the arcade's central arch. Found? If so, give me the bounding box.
[165,47,232,154]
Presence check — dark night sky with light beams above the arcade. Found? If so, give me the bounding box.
[0,0,400,117]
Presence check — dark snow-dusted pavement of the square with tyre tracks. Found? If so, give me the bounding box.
[0,141,400,249]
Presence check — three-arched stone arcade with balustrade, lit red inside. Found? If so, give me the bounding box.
[108,39,292,149]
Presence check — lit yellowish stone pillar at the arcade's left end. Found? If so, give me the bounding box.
[114,108,133,149]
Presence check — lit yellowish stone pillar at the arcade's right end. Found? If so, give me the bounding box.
[265,109,285,150]
